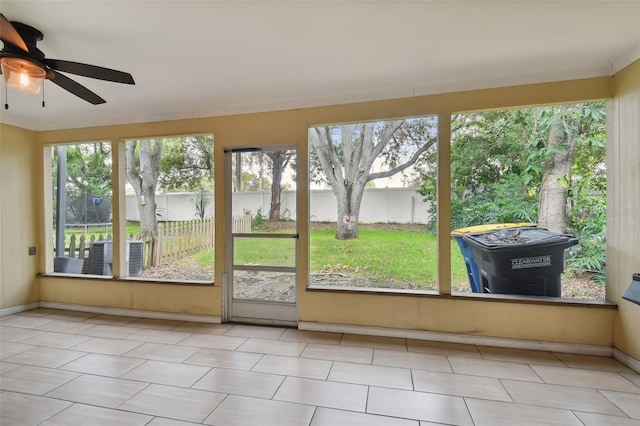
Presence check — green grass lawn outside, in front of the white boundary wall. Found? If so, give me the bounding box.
[196,227,469,288]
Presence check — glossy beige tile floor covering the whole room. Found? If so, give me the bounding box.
[0,309,640,426]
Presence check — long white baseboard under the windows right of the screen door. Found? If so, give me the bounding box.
[298,321,613,357]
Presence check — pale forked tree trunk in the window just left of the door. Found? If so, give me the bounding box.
[125,139,162,238]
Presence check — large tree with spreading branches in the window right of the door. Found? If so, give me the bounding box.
[309,118,437,240]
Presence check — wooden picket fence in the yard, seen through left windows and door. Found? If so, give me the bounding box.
[59,215,251,268]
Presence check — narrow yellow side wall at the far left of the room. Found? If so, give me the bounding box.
[0,125,40,309]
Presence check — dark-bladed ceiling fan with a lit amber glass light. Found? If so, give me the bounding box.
[0,13,135,106]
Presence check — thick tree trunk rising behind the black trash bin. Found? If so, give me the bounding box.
[538,117,575,234]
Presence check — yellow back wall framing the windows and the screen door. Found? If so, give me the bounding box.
[2,74,637,352]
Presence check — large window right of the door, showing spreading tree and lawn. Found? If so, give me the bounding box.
[309,117,438,291]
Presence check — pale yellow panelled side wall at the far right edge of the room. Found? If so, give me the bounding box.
[607,61,640,360]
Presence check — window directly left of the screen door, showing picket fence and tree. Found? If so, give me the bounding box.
[124,135,215,281]
